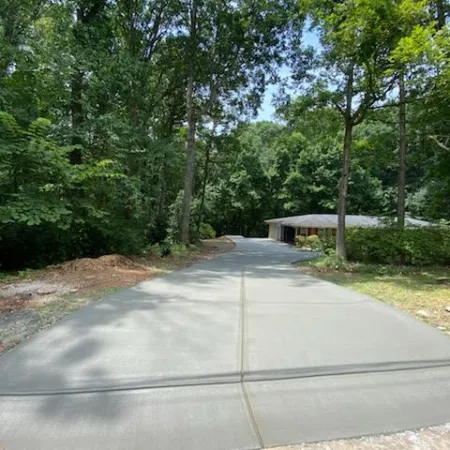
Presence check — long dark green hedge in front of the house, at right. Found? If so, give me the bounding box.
[346,228,450,265]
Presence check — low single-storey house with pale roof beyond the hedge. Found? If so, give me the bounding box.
[265,214,432,242]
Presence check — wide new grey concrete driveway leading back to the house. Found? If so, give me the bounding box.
[0,237,450,450]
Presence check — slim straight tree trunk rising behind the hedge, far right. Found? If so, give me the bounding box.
[397,73,407,229]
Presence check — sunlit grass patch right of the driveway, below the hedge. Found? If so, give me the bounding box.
[299,257,450,334]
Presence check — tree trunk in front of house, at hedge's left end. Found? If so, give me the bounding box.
[336,66,354,259]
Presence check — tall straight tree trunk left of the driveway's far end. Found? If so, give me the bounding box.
[181,0,197,244]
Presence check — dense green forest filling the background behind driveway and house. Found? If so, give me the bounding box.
[0,0,450,270]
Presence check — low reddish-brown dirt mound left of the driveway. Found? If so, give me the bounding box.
[53,255,145,273]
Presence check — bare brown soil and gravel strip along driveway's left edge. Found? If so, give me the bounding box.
[0,238,235,353]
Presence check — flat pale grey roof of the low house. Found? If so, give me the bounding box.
[265,214,432,228]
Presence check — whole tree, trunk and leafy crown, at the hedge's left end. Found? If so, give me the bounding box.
[291,0,404,258]
